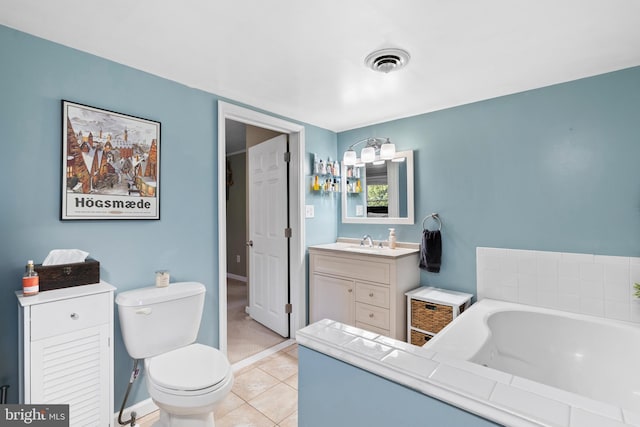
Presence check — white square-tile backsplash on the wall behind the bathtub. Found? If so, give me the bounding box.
[476,247,640,323]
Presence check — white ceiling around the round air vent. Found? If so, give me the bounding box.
[0,0,640,131]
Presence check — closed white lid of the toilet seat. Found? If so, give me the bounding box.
[147,344,231,391]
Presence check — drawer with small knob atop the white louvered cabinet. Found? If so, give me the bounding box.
[31,293,111,341]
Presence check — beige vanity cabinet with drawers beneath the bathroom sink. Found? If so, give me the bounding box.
[309,245,420,340]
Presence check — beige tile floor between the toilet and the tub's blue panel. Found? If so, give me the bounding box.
[138,343,298,427]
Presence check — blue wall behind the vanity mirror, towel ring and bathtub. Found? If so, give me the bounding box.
[338,67,640,294]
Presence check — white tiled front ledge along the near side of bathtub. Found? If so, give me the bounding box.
[296,319,640,427]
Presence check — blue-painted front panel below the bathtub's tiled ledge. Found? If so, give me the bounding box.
[298,346,497,427]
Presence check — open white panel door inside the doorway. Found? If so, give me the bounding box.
[248,135,289,337]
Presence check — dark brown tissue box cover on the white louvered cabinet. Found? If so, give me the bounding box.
[34,258,100,292]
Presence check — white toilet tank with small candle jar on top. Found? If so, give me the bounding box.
[116,282,205,359]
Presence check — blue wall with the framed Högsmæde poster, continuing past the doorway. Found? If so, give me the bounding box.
[0,26,337,407]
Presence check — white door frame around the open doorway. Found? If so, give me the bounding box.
[218,101,307,354]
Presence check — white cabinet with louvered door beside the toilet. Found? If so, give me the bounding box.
[16,282,115,427]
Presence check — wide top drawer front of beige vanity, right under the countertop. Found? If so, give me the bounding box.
[314,255,391,284]
